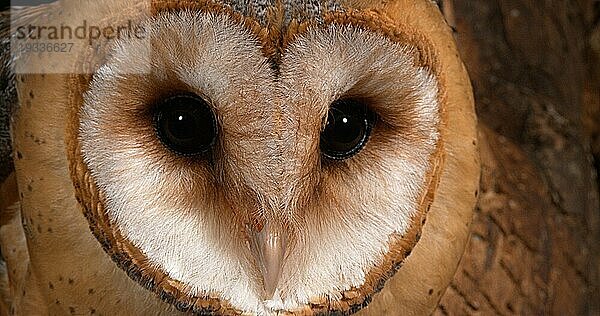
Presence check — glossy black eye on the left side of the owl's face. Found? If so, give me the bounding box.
[154,95,217,156]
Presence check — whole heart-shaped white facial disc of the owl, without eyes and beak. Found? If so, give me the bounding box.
[80,12,439,314]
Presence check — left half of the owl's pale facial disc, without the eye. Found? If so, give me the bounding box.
[80,12,274,312]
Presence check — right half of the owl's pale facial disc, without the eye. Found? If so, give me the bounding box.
[270,26,439,308]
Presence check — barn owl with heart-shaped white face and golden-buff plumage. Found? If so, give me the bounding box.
[1,0,479,315]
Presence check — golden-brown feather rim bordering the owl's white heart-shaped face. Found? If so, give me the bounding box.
[67,0,446,315]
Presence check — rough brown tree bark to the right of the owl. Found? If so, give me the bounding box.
[436,0,600,315]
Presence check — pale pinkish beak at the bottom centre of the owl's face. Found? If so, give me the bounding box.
[250,224,287,299]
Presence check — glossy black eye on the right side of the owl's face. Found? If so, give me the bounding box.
[321,100,372,159]
